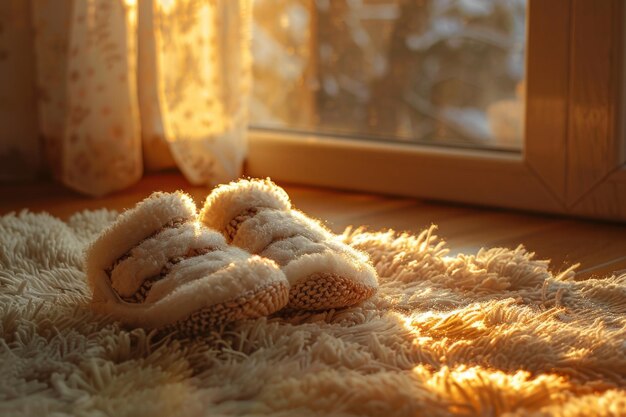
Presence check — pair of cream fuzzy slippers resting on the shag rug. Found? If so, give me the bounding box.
[86,180,378,336]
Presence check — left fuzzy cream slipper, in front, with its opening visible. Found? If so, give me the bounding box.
[86,192,289,336]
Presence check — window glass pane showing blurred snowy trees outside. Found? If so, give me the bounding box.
[251,0,526,150]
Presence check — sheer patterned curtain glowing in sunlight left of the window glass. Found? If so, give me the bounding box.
[0,0,252,195]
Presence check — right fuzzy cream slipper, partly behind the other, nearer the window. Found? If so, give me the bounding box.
[200,179,378,310]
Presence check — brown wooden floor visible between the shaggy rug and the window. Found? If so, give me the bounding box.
[0,173,626,278]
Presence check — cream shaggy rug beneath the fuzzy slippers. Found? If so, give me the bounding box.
[0,210,626,417]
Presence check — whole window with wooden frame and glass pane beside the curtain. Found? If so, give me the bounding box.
[248,0,626,220]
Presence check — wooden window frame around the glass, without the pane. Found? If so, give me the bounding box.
[246,0,626,221]
